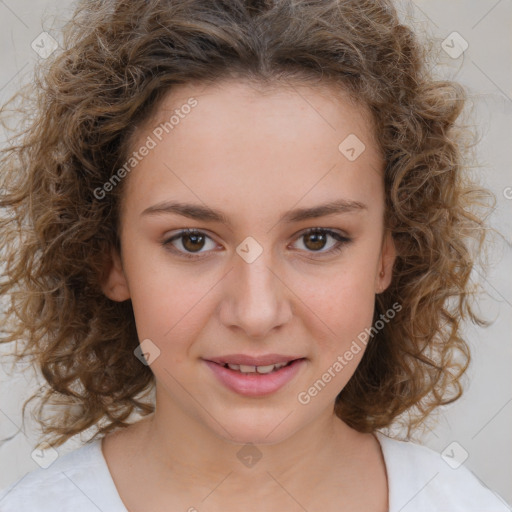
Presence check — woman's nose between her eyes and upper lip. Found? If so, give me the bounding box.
[219,251,292,338]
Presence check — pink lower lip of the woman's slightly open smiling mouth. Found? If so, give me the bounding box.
[205,359,306,396]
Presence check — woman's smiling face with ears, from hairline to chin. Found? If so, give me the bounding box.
[104,82,395,444]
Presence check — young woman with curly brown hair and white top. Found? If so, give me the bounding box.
[0,0,508,512]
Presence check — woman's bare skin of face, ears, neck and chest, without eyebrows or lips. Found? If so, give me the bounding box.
[103,81,396,512]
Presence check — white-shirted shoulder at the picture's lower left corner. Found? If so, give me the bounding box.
[0,439,126,512]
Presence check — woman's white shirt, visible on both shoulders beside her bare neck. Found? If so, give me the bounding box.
[0,433,511,512]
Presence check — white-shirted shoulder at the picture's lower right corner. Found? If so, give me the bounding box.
[377,433,511,512]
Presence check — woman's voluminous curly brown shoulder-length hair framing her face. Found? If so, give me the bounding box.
[0,0,491,446]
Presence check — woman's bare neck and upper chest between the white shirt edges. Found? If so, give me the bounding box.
[101,386,387,511]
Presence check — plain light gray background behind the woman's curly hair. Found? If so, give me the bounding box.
[0,0,512,503]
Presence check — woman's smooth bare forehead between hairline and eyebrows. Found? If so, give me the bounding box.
[120,81,383,220]
